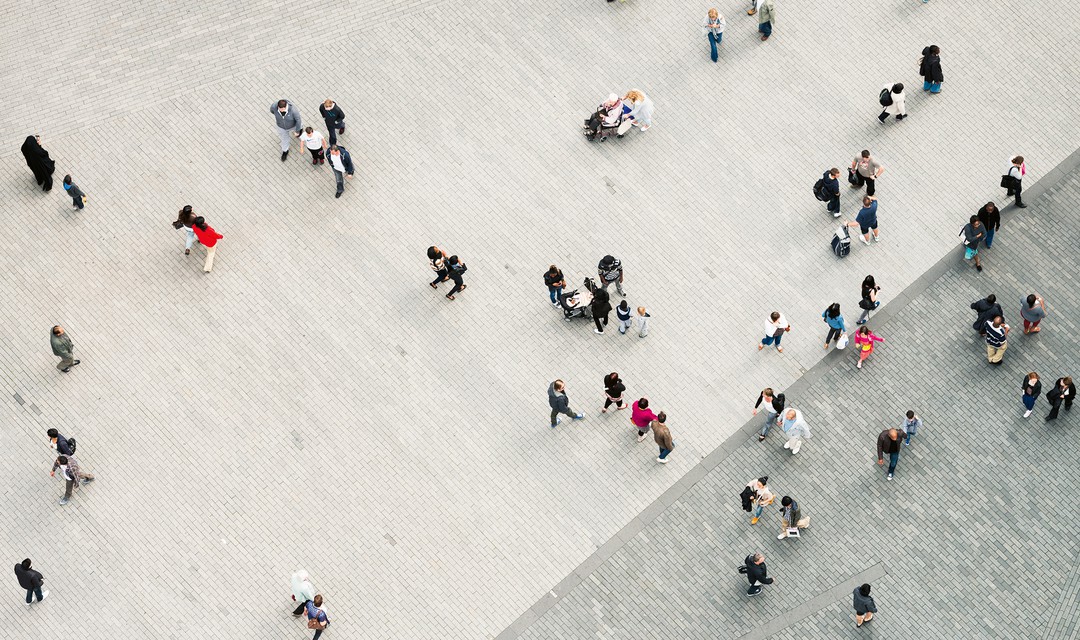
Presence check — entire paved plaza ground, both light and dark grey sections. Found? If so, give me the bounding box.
[0,0,1080,640]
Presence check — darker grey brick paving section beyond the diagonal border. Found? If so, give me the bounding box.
[504,162,1080,639]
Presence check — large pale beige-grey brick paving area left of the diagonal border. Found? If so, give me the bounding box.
[0,0,1080,639]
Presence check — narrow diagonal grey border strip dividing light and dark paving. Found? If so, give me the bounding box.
[496,148,1080,640]
